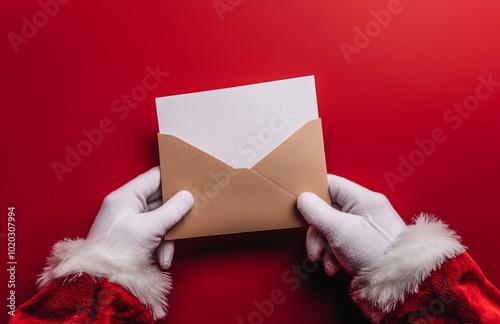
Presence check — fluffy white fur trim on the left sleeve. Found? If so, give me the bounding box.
[37,239,172,319]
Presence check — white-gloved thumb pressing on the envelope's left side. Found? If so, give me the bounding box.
[146,190,194,236]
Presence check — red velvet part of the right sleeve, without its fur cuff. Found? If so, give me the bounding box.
[382,253,500,323]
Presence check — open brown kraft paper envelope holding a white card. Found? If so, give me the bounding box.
[158,119,330,239]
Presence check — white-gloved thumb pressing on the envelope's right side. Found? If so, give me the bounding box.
[297,192,360,244]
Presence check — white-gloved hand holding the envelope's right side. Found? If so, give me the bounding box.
[297,175,406,276]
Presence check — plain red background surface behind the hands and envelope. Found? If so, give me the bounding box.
[0,0,500,323]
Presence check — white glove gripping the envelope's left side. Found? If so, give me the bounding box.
[87,167,194,269]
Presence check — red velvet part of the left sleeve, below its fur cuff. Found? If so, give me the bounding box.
[9,274,154,324]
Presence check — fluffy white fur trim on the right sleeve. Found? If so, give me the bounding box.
[351,214,466,322]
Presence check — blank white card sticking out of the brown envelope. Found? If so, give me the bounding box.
[156,76,318,168]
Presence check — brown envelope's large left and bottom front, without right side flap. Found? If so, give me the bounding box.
[158,134,304,239]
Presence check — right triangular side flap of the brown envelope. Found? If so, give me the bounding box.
[252,118,330,203]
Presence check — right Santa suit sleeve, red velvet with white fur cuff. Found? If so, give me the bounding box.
[351,216,500,323]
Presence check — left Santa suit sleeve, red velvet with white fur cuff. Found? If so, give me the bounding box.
[10,239,171,323]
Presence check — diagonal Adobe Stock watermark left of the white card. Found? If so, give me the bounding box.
[51,64,169,182]
